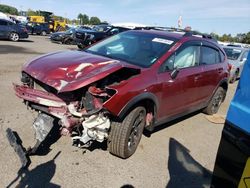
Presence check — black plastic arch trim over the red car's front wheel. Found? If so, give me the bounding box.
[118,92,159,119]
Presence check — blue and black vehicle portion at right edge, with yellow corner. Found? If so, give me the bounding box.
[211,54,250,188]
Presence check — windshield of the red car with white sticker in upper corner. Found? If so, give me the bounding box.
[86,31,175,67]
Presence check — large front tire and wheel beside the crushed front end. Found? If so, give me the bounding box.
[108,106,146,159]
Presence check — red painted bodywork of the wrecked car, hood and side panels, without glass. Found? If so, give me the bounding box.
[15,31,228,128]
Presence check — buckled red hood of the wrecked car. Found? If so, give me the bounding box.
[23,50,139,93]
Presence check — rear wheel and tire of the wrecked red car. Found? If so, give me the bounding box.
[203,87,226,115]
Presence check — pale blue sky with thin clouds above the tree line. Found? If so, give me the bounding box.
[0,0,250,35]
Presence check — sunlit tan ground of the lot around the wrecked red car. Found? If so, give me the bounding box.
[0,36,237,188]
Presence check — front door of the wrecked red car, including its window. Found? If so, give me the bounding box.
[158,41,202,120]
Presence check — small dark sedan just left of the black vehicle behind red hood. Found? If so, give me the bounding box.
[50,28,76,44]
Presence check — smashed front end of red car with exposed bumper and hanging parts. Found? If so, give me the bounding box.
[14,64,139,159]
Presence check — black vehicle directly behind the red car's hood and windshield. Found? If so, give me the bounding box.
[75,25,130,49]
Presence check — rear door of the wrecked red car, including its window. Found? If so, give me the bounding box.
[198,42,224,103]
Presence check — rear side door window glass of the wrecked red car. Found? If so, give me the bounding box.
[201,46,221,65]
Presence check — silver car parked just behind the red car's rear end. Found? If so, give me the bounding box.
[223,46,249,83]
